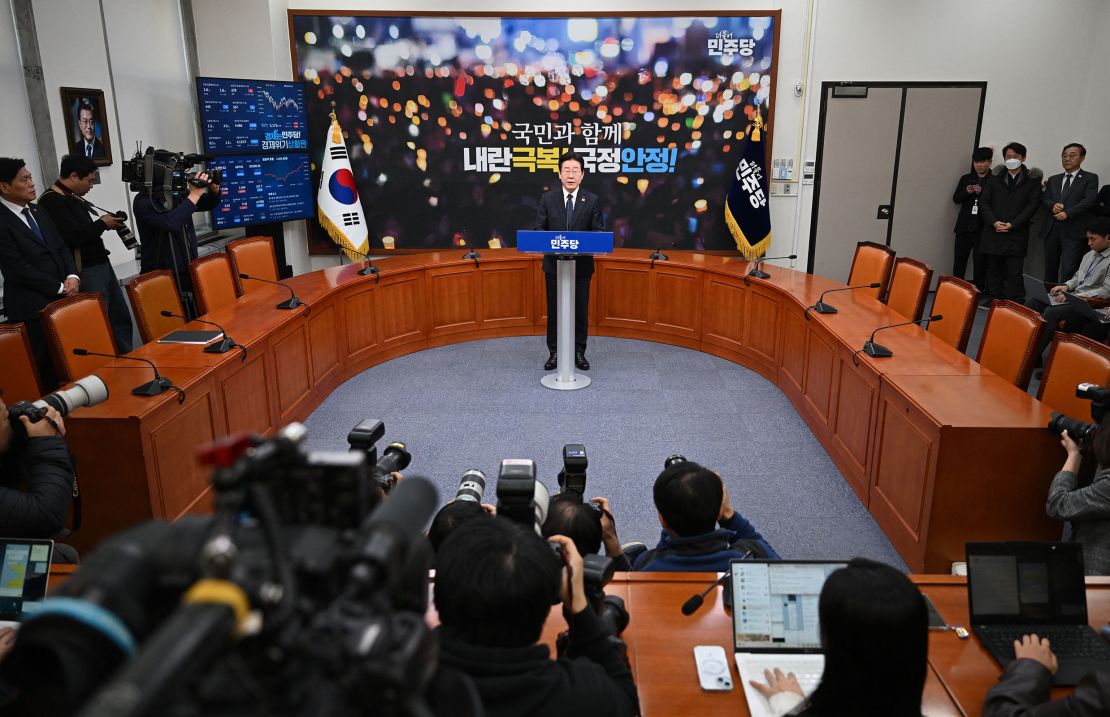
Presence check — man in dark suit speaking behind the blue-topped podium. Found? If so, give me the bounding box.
[535,152,605,371]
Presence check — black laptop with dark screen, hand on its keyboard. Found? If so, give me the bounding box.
[967,542,1110,686]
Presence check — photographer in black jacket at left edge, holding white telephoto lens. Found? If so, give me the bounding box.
[0,400,74,538]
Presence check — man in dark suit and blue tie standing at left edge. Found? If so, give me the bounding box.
[0,156,80,391]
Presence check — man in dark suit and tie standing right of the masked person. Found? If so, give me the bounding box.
[1041,142,1099,283]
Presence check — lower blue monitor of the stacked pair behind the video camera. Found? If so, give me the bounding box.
[209,154,316,229]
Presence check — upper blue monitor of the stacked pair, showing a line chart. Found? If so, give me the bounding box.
[196,78,309,154]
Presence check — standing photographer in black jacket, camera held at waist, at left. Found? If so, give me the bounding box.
[39,154,133,354]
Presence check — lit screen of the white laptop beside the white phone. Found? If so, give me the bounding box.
[729,561,846,653]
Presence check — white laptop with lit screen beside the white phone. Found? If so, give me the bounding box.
[729,561,847,717]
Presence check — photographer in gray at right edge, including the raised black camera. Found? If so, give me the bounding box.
[1045,383,1110,575]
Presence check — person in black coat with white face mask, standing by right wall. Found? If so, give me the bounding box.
[979,142,1043,303]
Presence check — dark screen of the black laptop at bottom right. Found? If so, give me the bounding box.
[967,542,1087,625]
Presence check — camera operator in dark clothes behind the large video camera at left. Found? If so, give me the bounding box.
[132,172,220,315]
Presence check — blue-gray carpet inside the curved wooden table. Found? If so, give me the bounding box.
[306,336,906,569]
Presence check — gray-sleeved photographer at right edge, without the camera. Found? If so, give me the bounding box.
[1045,426,1110,575]
